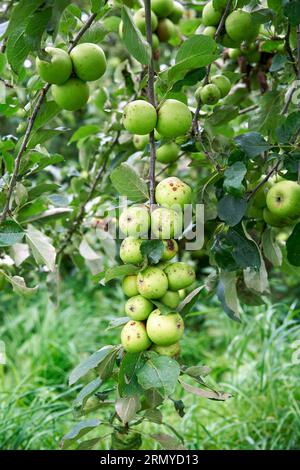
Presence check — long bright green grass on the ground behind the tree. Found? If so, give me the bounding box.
[0,281,300,450]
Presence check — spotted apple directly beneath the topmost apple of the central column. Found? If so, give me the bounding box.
[151,207,183,240]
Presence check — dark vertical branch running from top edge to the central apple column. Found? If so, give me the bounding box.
[145,0,156,211]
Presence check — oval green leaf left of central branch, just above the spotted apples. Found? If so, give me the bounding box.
[110,163,149,202]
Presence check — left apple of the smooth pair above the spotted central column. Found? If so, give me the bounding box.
[123,100,157,135]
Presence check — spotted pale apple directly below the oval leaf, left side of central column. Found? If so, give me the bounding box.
[119,205,150,237]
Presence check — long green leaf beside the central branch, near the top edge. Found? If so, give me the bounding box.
[122,6,151,65]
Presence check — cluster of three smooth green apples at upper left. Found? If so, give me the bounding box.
[36,43,106,111]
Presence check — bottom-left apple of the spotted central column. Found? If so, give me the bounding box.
[121,320,151,353]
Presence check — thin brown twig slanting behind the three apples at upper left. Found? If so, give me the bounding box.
[0,13,97,222]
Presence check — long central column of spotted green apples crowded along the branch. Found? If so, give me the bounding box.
[119,177,195,356]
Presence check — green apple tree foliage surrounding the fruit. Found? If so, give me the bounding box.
[0,0,300,449]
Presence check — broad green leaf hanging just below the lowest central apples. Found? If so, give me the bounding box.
[137,355,180,395]
